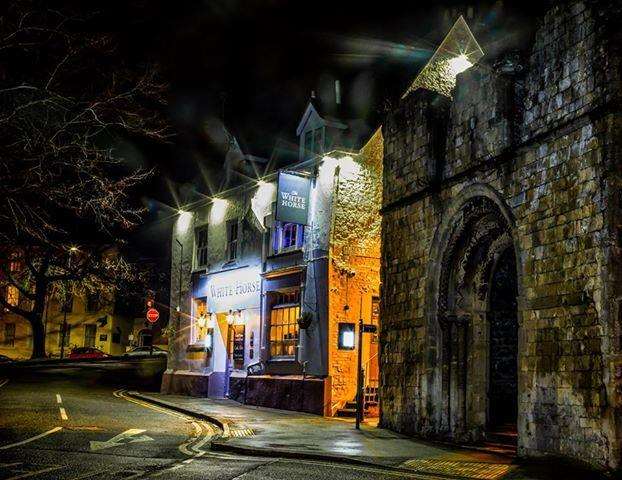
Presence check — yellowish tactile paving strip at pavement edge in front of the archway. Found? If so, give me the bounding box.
[402,459,513,480]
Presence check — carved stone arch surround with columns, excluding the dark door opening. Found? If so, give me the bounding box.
[428,186,518,441]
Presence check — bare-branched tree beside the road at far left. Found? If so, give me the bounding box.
[0,0,170,357]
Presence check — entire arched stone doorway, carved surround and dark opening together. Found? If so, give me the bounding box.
[431,189,518,441]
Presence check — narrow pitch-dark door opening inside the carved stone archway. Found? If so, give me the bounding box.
[488,248,518,434]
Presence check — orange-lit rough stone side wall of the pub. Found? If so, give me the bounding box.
[328,130,383,414]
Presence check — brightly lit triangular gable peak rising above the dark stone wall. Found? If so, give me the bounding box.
[402,16,484,98]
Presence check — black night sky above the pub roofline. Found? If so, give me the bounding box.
[53,0,533,258]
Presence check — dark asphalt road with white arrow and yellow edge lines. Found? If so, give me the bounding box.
[0,366,438,480]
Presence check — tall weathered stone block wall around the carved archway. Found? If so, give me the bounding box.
[381,2,622,468]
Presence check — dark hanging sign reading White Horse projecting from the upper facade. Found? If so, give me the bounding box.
[276,172,311,225]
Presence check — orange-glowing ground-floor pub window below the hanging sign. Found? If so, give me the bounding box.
[270,290,300,358]
